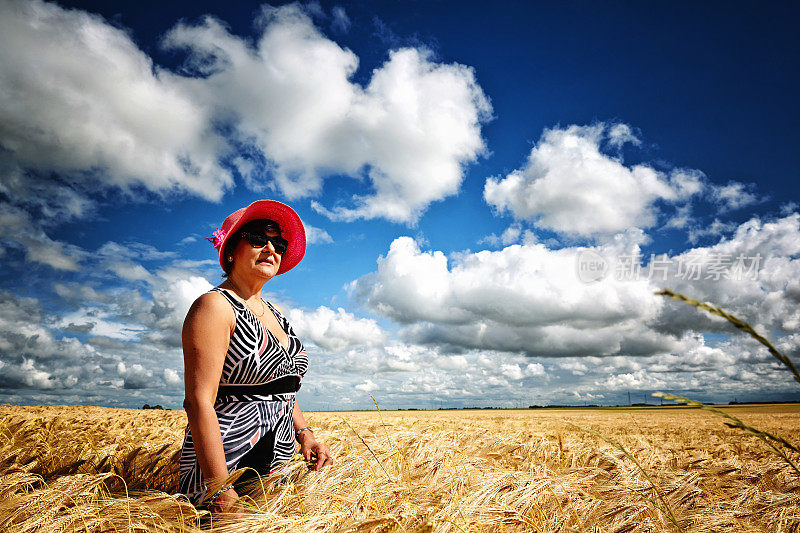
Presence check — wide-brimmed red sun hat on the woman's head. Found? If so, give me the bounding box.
[208,200,306,275]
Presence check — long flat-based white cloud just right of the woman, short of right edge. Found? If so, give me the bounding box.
[350,234,676,355]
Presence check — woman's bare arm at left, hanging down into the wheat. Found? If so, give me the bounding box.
[182,293,236,502]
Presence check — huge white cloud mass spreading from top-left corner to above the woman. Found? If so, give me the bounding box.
[0,0,491,227]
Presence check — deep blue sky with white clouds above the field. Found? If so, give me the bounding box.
[0,0,800,409]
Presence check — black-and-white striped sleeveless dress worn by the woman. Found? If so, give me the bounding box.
[180,287,308,505]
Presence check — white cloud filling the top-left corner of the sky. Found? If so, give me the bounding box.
[0,0,232,199]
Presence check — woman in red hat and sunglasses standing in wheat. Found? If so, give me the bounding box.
[180,200,333,511]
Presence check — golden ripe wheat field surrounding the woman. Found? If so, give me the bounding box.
[0,405,800,532]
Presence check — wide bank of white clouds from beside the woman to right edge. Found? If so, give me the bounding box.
[349,214,800,366]
